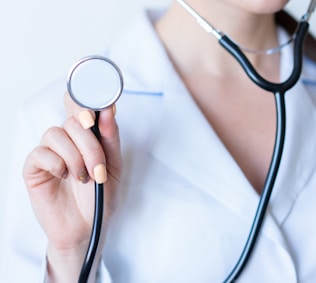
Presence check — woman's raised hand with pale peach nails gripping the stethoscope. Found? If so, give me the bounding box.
[23,94,121,282]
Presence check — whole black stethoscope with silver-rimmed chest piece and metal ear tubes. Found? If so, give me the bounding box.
[67,0,316,283]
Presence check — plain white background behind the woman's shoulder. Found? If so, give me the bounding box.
[0,0,316,272]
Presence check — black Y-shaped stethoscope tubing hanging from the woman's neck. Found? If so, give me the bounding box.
[219,21,309,283]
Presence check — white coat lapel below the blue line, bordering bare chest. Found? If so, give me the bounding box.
[150,71,257,215]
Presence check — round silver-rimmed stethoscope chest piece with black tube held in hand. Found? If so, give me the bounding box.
[67,56,123,283]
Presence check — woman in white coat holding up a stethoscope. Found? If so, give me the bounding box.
[5,0,316,283]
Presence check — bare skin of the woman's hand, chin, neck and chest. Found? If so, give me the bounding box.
[23,0,286,282]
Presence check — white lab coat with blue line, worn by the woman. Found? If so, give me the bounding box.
[1,8,316,283]
